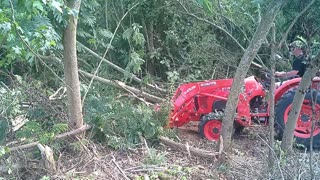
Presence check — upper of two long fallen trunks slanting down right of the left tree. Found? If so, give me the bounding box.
[77,42,166,93]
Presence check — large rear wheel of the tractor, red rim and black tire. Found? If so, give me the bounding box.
[275,91,320,148]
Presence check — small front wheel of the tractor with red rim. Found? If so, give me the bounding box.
[199,113,222,141]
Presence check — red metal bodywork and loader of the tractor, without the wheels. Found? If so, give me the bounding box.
[169,76,320,131]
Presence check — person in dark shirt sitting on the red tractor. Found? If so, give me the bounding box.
[275,42,306,78]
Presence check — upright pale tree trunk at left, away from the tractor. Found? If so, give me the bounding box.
[63,0,83,129]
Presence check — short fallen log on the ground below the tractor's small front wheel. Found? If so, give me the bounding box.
[159,136,219,159]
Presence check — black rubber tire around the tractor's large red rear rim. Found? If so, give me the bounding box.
[275,91,320,148]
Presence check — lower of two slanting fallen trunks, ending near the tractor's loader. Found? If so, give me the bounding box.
[79,70,163,103]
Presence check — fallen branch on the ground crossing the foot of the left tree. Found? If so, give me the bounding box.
[9,125,91,152]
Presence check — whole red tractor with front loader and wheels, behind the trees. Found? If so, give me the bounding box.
[169,76,320,147]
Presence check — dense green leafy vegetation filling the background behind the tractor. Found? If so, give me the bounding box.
[0,0,320,178]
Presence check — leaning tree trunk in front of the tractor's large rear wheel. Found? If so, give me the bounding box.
[281,52,320,152]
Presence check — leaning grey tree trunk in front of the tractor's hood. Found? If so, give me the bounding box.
[221,0,285,151]
